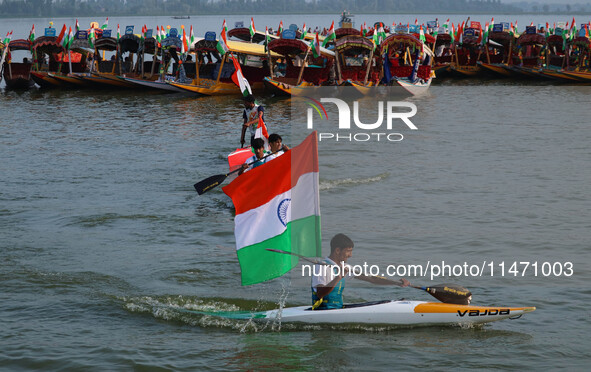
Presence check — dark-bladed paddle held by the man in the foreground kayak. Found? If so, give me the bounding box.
[267,248,472,305]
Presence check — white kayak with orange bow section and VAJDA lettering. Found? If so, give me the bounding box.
[262,300,536,325]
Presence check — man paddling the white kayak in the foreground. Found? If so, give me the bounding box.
[312,234,410,310]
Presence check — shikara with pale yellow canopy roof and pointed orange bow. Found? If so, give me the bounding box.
[168,37,277,96]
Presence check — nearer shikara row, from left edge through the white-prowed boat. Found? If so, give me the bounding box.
[3,18,434,95]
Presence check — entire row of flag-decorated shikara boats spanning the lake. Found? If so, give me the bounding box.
[0,18,591,96]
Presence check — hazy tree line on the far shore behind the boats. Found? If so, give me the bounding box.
[0,0,522,17]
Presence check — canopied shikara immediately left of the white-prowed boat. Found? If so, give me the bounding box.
[335,35,381,95]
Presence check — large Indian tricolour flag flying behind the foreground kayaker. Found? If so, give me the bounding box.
[223,132,321,285]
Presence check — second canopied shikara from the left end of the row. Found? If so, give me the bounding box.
[31,36,64,88]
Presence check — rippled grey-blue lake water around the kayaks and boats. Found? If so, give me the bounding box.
[0,15,591,371]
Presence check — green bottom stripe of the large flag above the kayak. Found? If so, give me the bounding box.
[236,215,322,285]
